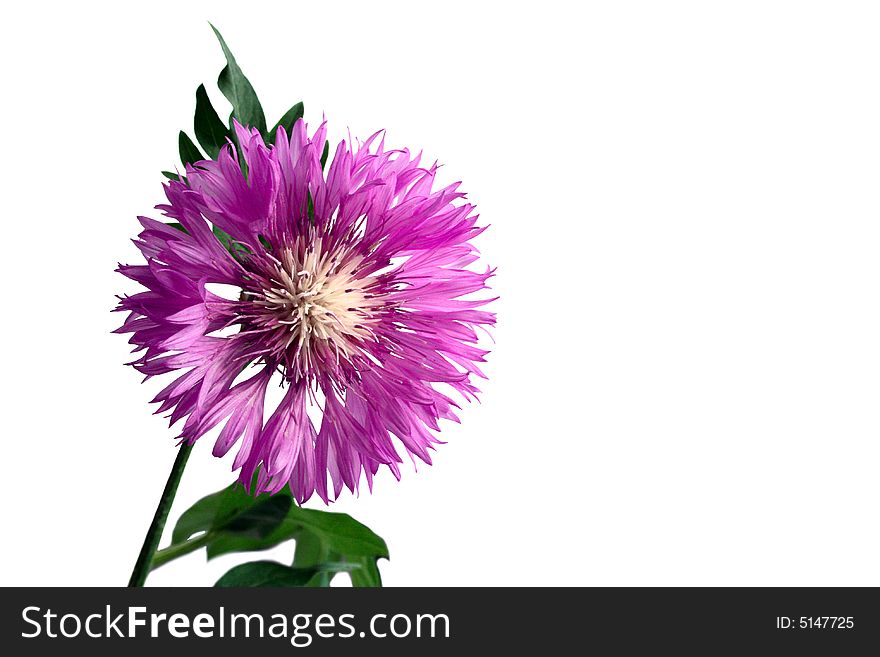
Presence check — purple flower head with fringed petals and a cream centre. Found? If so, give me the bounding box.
[117,121,495,502]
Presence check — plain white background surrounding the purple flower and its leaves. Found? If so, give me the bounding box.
[0,1,880,586]
